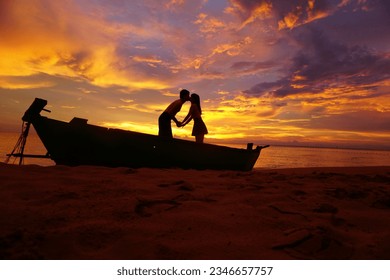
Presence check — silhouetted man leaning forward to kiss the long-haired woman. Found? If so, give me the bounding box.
[158,89,190,138]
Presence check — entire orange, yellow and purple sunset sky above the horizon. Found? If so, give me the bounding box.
[0,0,390,149]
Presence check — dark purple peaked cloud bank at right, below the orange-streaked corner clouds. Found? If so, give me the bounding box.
[245,29,390,97]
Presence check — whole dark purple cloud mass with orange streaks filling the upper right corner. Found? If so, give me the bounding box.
[232,0,390,97]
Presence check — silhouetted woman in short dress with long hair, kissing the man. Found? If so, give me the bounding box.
[182,93,208,143]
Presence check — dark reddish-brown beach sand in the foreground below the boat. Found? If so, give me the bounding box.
[0,164,390,260]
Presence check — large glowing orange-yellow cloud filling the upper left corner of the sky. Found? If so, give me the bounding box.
[0,0,167,89]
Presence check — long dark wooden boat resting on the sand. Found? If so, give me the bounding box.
[12,98,264,171]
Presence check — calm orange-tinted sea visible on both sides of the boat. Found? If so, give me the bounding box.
[0,132,390,169]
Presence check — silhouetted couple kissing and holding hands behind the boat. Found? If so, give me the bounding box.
[158,89,208,143]
